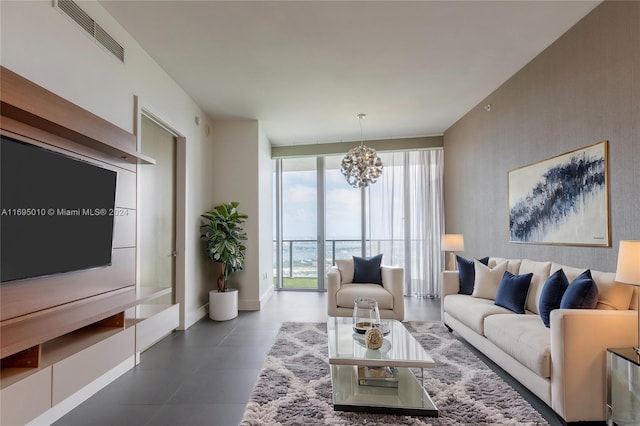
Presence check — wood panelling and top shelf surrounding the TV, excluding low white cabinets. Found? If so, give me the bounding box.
[0,68,145,358]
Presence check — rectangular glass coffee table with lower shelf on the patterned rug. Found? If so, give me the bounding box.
[327,317,438,417]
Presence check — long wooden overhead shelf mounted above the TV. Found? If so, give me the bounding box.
[0,67,155,164]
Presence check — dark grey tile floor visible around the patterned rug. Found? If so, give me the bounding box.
[55,292,562,426]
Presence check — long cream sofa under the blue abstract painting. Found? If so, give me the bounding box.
[441,258,638,422]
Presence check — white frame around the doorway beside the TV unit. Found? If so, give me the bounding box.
[134,96,187,330]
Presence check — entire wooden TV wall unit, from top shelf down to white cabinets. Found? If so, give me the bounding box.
[0,67,178,424]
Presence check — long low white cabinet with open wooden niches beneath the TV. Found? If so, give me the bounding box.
[0,289,179,426]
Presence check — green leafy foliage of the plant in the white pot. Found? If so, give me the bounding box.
[200,201,248,291]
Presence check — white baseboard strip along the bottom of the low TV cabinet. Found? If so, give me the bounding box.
[27,355,135,426]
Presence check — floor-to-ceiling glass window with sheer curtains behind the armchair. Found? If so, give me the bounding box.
[274,149,444,297]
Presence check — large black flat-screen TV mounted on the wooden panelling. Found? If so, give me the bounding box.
[0,136,117,283]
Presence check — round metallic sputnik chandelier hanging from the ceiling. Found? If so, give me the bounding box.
[340,114,382,188]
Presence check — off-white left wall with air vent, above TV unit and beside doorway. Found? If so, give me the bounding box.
[0,0,217,327]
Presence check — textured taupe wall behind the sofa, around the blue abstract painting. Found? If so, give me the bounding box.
[444,1,640,271]
